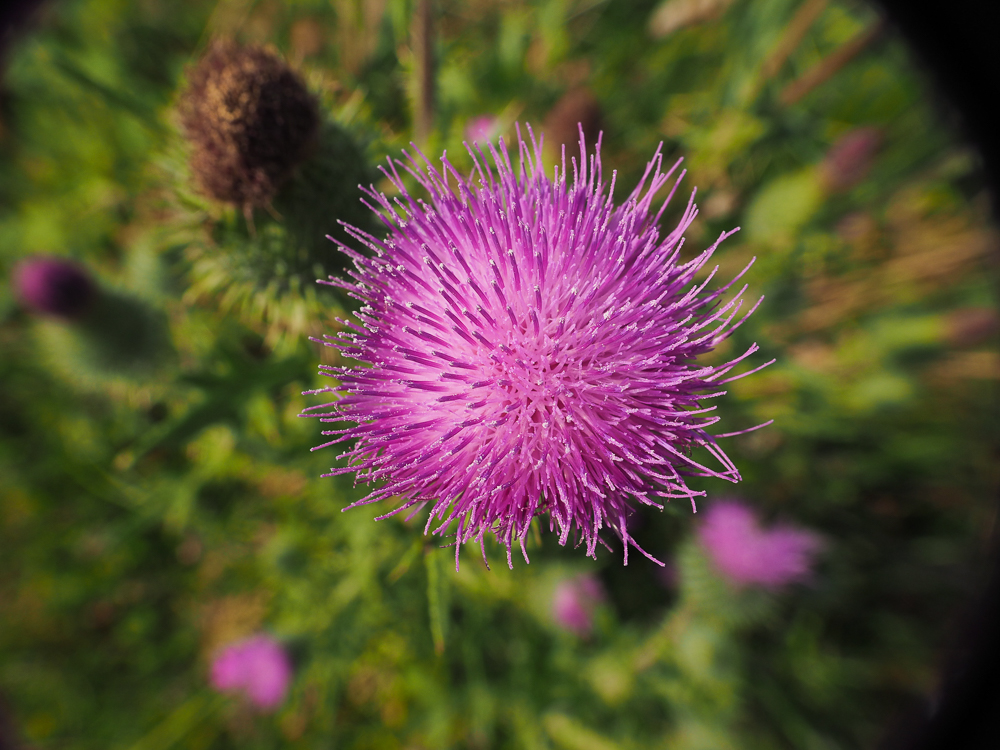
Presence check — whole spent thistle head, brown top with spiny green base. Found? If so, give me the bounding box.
[174,42,378,347]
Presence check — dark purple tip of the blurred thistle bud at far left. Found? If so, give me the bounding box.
[14,256,97,320]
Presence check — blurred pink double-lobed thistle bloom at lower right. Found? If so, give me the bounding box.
[698,500,820,588]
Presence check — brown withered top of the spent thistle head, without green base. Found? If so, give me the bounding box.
[180,42,319,207]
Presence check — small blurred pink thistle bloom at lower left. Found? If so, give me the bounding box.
[211,635,292,711]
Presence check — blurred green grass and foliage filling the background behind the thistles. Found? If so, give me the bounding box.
[0,0,1000,750]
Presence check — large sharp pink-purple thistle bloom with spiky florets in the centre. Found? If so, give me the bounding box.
[304,126,772,565]
